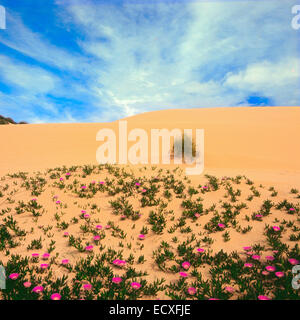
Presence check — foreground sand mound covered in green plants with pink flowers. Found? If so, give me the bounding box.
[0,165,300,300]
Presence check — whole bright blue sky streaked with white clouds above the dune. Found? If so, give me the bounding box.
[0,0,300,123]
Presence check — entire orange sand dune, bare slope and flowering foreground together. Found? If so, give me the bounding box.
[0,107,300,300]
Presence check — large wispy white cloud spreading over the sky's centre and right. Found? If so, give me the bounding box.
[58,1,299,120]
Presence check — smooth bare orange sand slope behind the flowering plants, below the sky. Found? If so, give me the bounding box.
[0,107,300,185]
